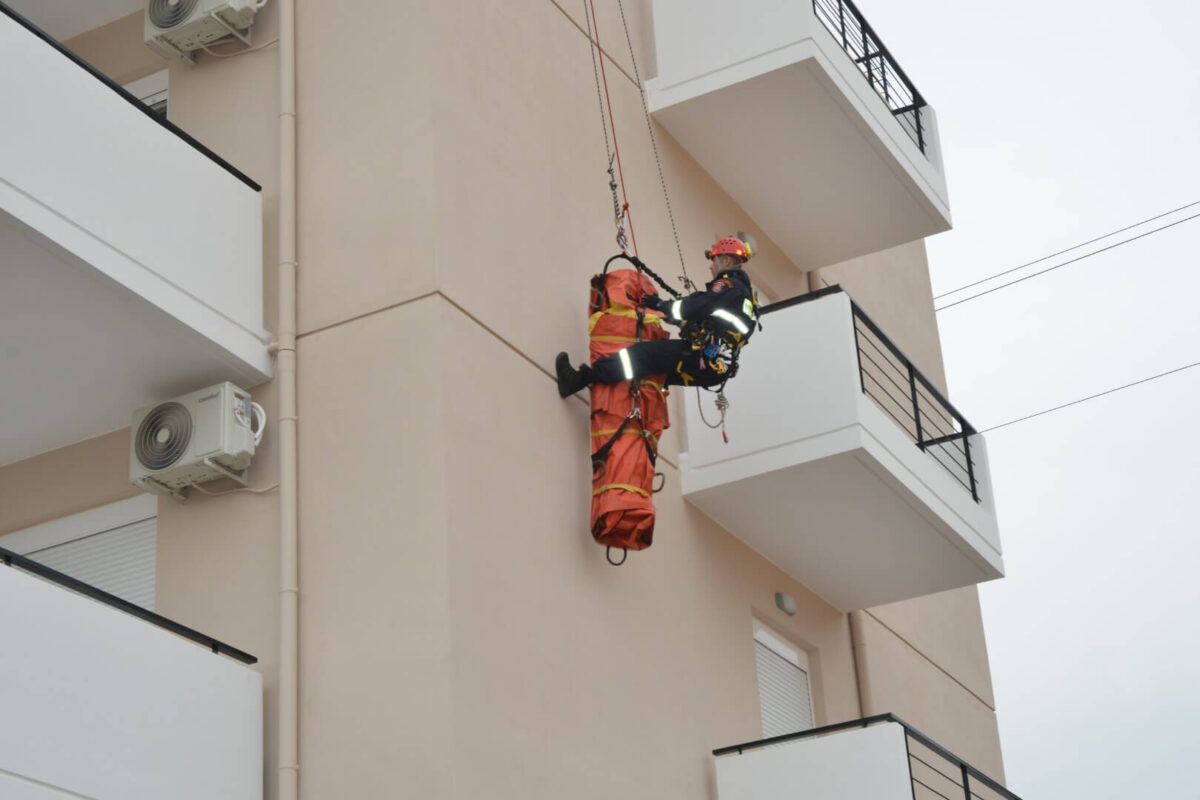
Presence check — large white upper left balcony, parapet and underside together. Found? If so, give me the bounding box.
[0,6,271,464]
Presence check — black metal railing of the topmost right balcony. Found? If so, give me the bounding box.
[812,0,928,152]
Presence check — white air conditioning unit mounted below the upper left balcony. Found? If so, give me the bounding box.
[130,383,266,500]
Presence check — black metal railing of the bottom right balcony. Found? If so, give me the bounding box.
[713,714,1021,800]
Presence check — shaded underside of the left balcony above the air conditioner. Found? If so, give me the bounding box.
[0,211,269,464]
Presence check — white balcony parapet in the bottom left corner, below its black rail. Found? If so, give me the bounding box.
[0,566,263,800]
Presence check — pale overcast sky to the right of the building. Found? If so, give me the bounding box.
[857,0,1200,800]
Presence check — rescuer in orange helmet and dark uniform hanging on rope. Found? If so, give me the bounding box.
[554,236,758,397]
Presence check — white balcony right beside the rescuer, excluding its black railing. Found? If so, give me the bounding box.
[679,293,1003,610]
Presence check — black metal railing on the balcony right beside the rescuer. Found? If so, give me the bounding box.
[760,285,979,503]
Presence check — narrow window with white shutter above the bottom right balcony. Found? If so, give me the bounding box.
[754,620,812,739]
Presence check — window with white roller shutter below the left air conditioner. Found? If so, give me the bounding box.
[0,494,158,610]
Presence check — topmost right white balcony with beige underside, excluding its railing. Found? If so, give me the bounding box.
[646,0,950,270]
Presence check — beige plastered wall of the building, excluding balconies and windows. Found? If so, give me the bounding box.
[0,0,1001,798]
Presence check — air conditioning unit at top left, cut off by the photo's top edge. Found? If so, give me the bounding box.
[145,0,266,64]
